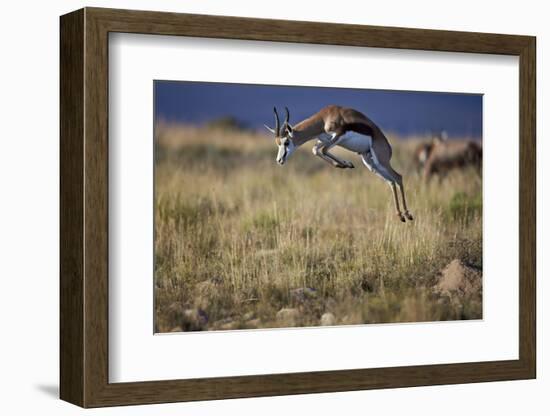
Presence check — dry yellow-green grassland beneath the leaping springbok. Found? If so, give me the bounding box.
[155,124,482,332]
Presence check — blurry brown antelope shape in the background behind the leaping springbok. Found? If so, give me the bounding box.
[422,135,482,180]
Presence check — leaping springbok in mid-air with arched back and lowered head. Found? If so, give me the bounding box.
[265,105,413,222]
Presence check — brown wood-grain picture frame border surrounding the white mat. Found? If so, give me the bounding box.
[60,8,536,407]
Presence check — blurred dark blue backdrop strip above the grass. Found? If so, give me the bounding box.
[154,81,482,139]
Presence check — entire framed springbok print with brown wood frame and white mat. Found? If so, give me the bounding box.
[60,8,536,407]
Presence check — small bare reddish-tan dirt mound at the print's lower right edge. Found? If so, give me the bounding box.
[434,259,482,298]
